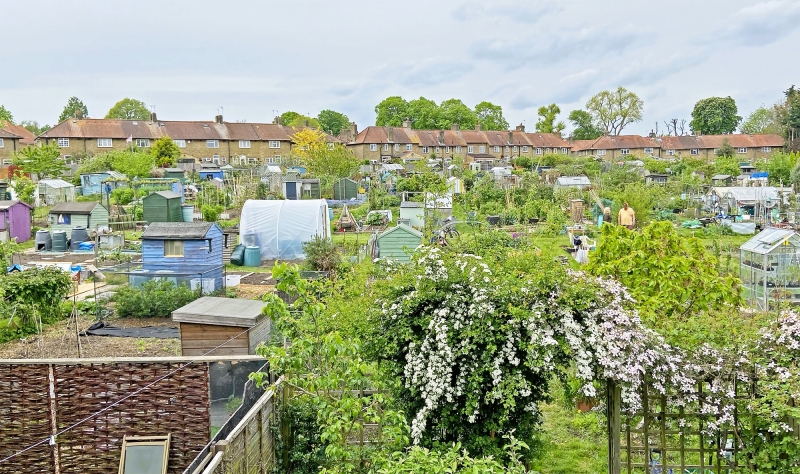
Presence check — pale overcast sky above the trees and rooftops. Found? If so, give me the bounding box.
[0,0,800,134]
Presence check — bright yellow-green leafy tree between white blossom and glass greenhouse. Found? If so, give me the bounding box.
[587,222,742,320]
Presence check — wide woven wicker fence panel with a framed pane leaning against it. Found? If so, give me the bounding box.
[55,363,210,474]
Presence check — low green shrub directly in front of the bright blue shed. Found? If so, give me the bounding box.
[114,280,198,318]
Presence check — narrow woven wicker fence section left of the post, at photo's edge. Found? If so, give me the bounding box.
[0,365,53,474]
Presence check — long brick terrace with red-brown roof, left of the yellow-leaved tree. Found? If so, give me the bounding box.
[38,114,339,165]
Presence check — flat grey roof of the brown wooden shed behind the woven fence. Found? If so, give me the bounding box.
[172,296,266,327]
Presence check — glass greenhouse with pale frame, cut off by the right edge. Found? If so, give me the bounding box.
[739,227,800,311]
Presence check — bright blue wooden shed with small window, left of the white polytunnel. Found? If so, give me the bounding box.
[141,222,224,293]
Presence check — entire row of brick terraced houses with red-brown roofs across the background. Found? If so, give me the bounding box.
[0,114,784,169]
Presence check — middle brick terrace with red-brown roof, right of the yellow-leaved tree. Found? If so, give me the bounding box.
[346,121,571,169]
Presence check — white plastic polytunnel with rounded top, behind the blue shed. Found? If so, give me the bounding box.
[239,199,330,260]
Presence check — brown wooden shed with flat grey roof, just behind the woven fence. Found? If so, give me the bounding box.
[172,296,272,356]
